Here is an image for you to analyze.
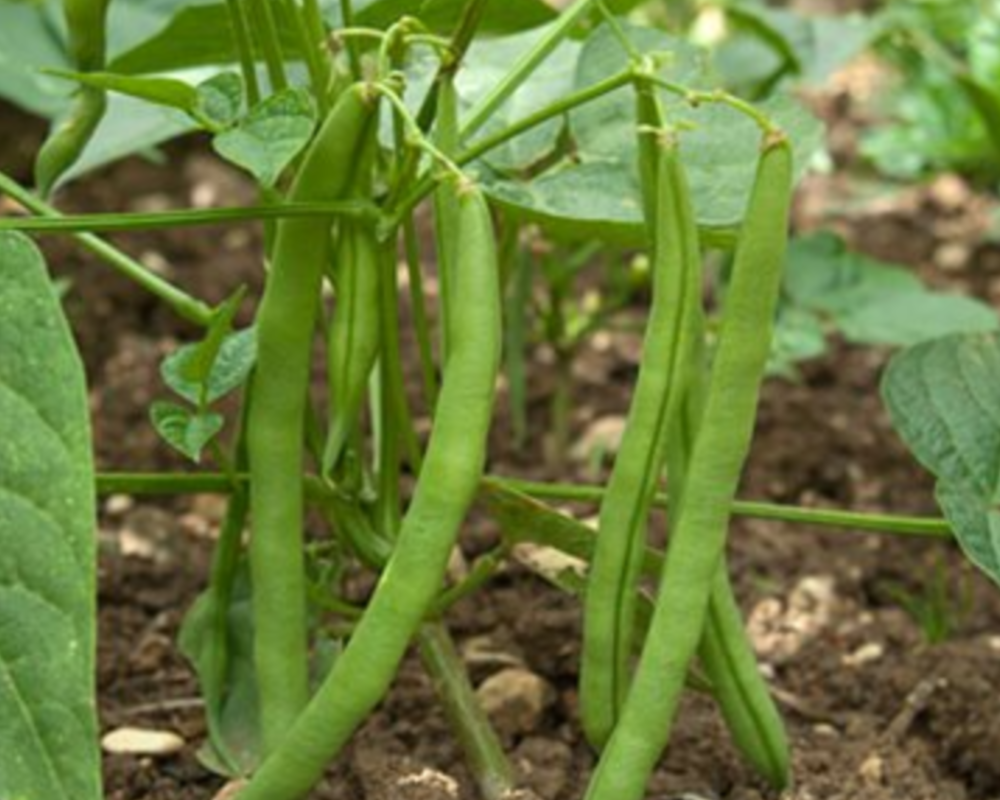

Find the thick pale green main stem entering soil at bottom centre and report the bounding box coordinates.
[417,622,514,800]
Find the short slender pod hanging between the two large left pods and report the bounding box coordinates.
[323,219,380,471]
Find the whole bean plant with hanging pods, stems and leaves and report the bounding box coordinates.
[0,0,1000,800]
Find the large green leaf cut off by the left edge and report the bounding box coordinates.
[0,233,102,800]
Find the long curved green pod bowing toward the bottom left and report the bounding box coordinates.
[239,182,501,800]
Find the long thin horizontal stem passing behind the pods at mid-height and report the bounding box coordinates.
[97,472,953,540]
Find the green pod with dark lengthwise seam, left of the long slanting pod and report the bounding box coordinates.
[580,132,701,748]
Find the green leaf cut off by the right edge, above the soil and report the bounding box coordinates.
[882,333,1000,584]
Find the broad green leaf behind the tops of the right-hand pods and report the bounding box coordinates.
[478,26,821,244]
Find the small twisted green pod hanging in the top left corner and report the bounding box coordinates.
[35,0,110,196]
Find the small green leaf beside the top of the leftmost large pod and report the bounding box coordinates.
[212,89,316,187]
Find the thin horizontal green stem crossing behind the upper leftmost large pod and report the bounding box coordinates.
[0,200,376,233]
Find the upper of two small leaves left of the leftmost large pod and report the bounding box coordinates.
[160,328,257,406]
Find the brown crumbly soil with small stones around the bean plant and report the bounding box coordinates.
[0,43,1000,800]
